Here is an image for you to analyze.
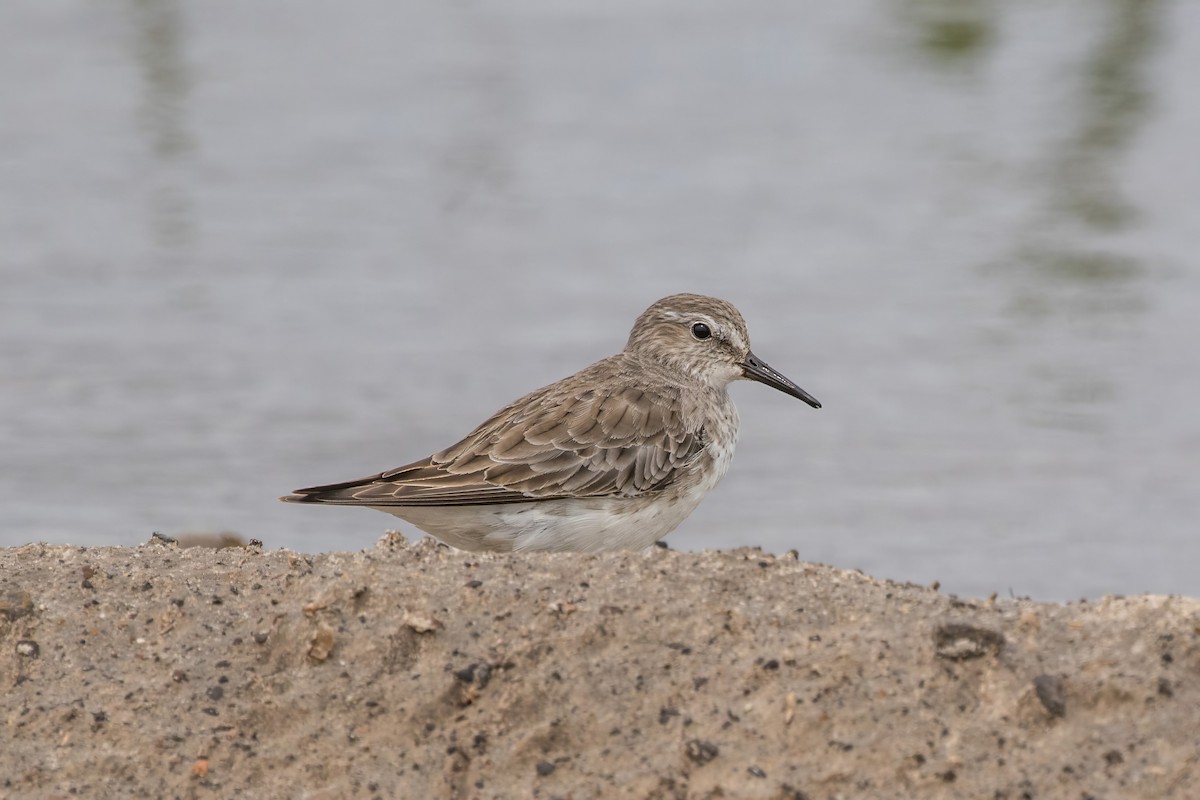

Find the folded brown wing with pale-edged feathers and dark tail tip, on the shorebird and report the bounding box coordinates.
[282,354,704,506]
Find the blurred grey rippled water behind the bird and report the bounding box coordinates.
[0,0,1200,600]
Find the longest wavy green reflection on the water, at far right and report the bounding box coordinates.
[986,0,1163,433]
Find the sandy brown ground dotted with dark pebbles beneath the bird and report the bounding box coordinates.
[0,537,1200,800]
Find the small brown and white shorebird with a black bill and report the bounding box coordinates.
[280,294,821,553]
